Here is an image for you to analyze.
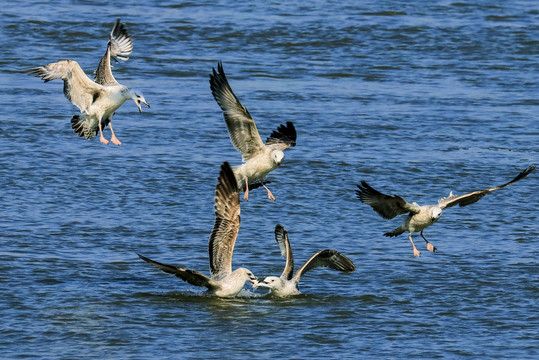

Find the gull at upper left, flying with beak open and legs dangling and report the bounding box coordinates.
[26,19,150,145]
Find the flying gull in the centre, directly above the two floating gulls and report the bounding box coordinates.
[210,62,296,200]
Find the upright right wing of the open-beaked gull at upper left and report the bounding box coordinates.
[95,19,133,85]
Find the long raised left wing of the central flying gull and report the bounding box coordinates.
[210,62,265,161]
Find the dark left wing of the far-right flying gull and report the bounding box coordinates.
[356,180,420,219]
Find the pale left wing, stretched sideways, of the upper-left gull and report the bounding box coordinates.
[26,60,104,111]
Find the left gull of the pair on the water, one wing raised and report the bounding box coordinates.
[138,162,257,297]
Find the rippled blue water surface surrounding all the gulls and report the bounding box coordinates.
[0,0,539,359]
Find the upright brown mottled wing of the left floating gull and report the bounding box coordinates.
[208,162,240,280]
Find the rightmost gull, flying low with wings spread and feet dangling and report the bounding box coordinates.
[356,165,535,256]
